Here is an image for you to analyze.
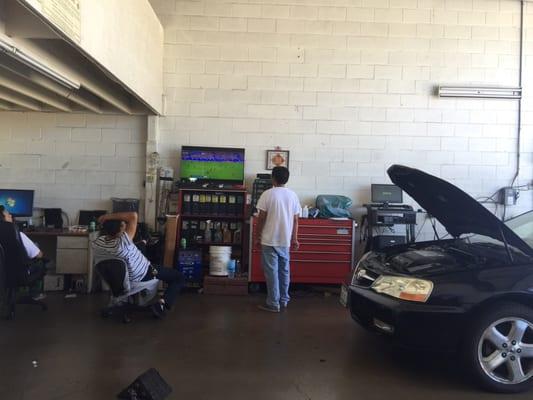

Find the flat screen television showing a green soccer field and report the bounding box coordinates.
[180,146,244,184]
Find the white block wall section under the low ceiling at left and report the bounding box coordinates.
[0,112,146,224]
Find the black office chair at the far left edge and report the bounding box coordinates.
[0,221,48,319]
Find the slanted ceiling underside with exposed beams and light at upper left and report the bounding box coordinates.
[0,0,156,115]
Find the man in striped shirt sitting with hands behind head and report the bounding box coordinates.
[92,212,182,318]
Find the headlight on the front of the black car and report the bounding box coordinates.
[371,275,433,303]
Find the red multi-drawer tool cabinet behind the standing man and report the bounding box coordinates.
[248,218,357,284]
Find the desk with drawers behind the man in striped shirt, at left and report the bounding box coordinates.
[24,230,96,293]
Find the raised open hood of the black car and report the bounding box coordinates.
[387,165,533,255]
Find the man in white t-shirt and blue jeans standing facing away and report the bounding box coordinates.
[255,167,300,312]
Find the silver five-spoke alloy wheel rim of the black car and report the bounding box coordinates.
[478,317,533,385]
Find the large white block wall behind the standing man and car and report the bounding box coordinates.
[151,0,533,234]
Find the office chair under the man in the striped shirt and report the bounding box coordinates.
[95,259,159,323]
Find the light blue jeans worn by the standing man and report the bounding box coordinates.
[261,246,291,308]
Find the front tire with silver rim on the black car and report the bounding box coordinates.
[463,302,533,393]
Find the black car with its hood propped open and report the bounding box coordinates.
[341,165,533,392]
